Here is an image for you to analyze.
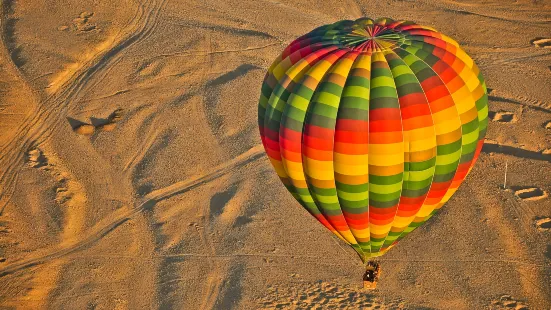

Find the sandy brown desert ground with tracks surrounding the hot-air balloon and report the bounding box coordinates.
[0,0,551,309]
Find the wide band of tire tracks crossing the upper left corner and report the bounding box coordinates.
[0,0,167,213]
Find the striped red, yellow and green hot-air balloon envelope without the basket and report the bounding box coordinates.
[258,18,488,262]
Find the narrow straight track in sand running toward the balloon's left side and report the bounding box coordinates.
[0,145,264,278]
